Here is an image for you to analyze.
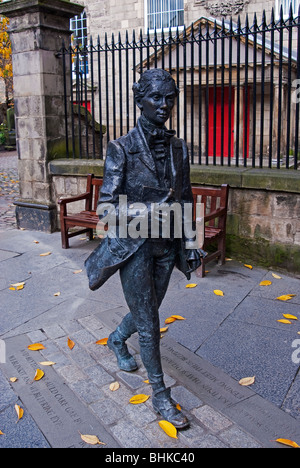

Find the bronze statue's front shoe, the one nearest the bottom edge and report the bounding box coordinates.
[152,388,189,429]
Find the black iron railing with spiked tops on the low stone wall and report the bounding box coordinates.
[60,10,300,169]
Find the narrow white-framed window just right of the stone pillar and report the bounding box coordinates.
[70,12,89,75]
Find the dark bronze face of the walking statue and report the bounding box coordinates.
[139,79,176,127]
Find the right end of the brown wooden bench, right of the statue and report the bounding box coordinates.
[192,184,229,278]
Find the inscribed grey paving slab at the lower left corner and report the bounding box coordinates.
[0,335,118,448]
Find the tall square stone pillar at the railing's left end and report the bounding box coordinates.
[0,0,84,232]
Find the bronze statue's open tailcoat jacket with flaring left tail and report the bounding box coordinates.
[85,121,193,290]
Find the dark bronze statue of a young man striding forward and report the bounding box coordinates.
[86,69,203,428]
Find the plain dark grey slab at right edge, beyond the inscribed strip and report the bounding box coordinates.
[197,320,299,407]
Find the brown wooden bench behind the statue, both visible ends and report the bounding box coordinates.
[58,174,229,277]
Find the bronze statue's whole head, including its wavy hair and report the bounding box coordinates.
[132,68,179,127]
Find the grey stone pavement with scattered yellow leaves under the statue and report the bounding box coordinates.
[0,151,300,453]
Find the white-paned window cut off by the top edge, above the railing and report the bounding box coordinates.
[145,0,184,31]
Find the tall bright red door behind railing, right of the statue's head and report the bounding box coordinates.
[208,86,234,157]
